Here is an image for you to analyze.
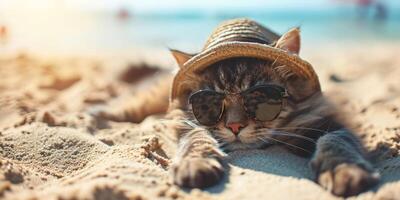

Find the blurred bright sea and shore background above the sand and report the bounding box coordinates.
[0,0,400,55]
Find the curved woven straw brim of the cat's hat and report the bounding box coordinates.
[170,41,321,100]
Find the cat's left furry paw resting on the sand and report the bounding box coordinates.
[172,158,224,188]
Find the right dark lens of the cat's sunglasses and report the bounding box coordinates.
[244,86,282,121]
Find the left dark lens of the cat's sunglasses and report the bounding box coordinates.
[189,91,224,126]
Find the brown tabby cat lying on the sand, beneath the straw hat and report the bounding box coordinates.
[97,21,379,197]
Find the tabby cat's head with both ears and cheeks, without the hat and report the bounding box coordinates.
[172,29,327,151]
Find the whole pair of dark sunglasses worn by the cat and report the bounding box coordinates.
[189,85,289,126]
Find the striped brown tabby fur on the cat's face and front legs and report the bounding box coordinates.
[169,58,378,196]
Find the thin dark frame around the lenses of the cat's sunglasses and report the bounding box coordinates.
[188,84,289,126]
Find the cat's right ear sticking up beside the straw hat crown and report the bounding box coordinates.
[275,27,300,55]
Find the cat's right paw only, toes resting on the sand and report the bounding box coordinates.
[317,163,379,197]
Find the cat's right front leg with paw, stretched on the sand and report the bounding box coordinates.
[310,129,379,197]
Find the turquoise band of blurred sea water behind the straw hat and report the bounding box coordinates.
[131,8,400,48]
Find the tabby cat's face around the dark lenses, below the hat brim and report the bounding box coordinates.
[188,58,293,150]
